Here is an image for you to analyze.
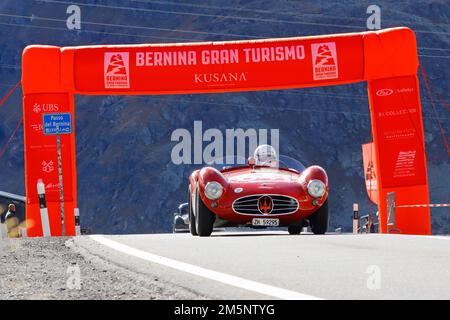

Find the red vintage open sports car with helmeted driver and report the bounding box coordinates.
[188,146,328,236]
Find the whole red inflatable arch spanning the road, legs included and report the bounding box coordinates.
[22,28,431,236]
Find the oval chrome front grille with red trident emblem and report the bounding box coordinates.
[233,194,299,215]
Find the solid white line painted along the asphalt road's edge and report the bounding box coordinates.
[90,235,321,300]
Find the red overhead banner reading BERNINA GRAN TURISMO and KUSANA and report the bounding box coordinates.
[73,37,364,94]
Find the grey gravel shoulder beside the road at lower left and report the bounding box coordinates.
[0,237,204,300]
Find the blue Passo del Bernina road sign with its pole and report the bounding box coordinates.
[42,113,72,236]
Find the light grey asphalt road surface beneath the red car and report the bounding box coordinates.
[75,232,450,299]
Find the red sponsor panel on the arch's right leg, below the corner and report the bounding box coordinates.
[371,77,426,188]
